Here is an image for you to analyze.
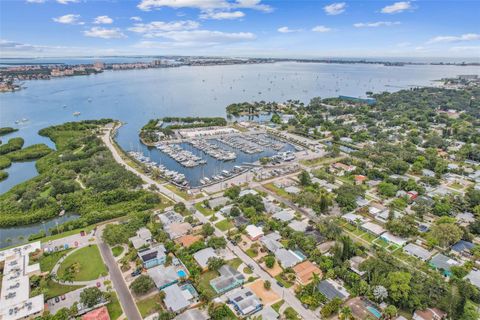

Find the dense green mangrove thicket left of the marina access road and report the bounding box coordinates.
[0,119,161,228]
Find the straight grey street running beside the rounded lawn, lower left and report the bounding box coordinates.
[96,226,142,320]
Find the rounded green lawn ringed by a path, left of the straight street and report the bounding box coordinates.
[58,245,107,281]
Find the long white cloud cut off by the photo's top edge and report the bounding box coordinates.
[137,0,272,12]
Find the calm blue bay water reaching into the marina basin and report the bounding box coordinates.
[0,62,480,242]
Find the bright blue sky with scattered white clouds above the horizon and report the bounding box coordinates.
[0,0,480,59]
